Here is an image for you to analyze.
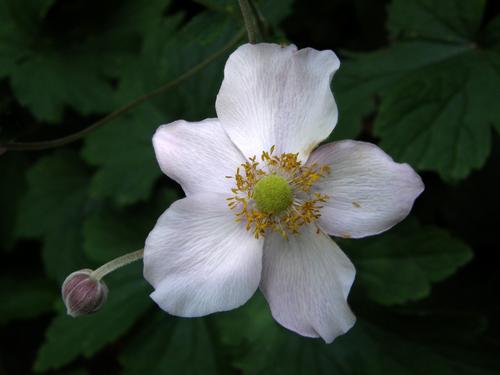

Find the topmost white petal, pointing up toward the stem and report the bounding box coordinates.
[216,43,340,161]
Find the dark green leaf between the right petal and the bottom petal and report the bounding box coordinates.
[341,220,473,305]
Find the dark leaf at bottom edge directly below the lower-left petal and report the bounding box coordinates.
[120,312,219,375]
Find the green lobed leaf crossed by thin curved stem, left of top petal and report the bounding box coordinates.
[83,12,242,206]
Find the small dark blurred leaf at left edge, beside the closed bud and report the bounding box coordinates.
[0,275,59,324]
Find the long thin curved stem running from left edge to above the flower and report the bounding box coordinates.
[0,30,245,151]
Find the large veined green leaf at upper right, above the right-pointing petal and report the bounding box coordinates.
[375,51,500,180]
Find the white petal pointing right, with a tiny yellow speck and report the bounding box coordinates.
[308,141,424,238]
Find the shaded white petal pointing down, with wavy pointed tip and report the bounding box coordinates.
[260,225,356,343]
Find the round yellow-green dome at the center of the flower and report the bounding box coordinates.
[253,174,293,214]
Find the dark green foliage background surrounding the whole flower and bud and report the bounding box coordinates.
[0,0,500,375]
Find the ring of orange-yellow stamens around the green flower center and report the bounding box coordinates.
[226,146,330,238]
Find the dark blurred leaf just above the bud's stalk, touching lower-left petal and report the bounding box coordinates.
[83,190,180,263]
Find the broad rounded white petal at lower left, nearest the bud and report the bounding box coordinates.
[144,194,263,317]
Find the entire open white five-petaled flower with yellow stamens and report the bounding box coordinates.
[144,44,424,343]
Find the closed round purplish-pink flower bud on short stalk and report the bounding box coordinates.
[61,269,108,318]
